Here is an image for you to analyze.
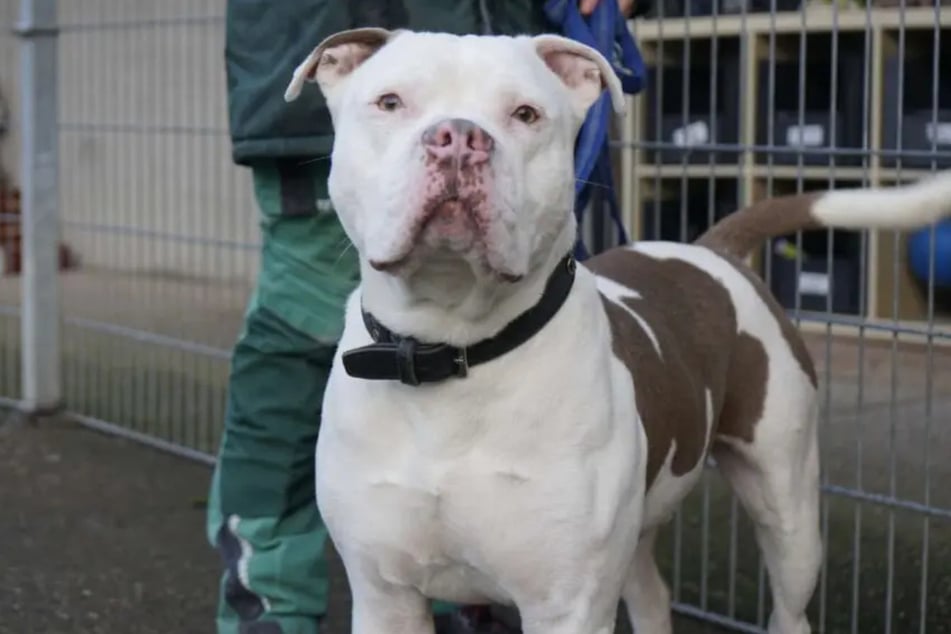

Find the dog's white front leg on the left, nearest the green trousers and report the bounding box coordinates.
[350,575,435,634]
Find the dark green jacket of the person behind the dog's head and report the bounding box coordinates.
[225,0,554,165]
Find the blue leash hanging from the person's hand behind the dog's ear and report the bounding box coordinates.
[545,0,645,260]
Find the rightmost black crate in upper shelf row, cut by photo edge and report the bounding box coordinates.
[882,49,951,168]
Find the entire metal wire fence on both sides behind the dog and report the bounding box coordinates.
[0,0,951,634]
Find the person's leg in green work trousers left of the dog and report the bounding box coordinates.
[207,162,357,634]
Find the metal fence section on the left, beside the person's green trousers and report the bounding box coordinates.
[0,0,258,455]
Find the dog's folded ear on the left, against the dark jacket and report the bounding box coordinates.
[284,28,399,101]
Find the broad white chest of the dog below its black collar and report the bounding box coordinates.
[318,324,643,602]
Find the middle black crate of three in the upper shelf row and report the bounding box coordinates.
[756,46,865,165]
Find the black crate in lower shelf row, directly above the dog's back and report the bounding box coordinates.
[641,180,737,242]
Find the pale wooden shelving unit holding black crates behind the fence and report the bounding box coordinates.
[619,5,951,334]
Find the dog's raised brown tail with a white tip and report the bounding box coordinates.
[696,170,951,258]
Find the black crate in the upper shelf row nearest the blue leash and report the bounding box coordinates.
[642,40,740,164]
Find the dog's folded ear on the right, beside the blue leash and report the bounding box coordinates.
[532,35,624,114]
